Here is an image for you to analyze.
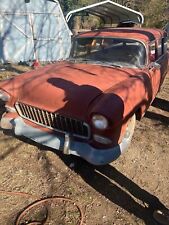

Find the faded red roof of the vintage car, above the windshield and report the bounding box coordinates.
[77,27,164,42]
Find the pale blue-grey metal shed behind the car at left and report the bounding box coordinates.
[0,0,71,63]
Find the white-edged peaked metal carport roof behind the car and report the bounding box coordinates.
[66,0,144,24]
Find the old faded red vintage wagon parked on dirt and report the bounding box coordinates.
[0,28,169,165]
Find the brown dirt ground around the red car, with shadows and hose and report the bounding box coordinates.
[0,63,169,225]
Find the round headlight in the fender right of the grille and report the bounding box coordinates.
[92,115,108,130]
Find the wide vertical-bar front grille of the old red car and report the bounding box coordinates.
[15,102,90,139]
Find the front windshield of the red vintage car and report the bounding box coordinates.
[70,37,146,67]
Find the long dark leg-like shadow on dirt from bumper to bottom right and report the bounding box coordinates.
[60,155,165,225]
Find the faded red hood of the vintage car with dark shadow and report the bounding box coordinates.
[0,62,141,119]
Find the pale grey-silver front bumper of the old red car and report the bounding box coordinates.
[1,117,130,165]
